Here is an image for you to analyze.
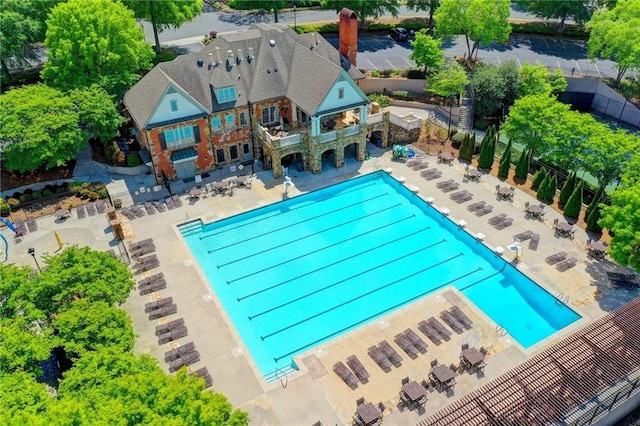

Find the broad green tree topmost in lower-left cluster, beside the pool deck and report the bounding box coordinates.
[31,246,134,313]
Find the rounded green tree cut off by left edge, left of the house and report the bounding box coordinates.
[0,84,86,173]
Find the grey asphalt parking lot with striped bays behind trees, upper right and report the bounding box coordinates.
[327,33,616,77]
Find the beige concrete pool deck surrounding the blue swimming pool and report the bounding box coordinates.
[2,145,638,425]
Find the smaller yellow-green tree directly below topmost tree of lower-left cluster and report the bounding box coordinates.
[52,299,135,357]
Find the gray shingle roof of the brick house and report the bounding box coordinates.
[124,24,364,128]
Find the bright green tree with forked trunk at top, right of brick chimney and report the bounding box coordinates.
[435,0,511,68]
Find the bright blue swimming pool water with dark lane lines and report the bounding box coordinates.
[180,172,579,375]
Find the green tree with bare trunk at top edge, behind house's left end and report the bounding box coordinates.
[122,0,200,53]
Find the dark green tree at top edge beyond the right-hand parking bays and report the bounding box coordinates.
[514,0,593,34]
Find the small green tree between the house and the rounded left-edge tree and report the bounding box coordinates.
[69,84,125,143]
